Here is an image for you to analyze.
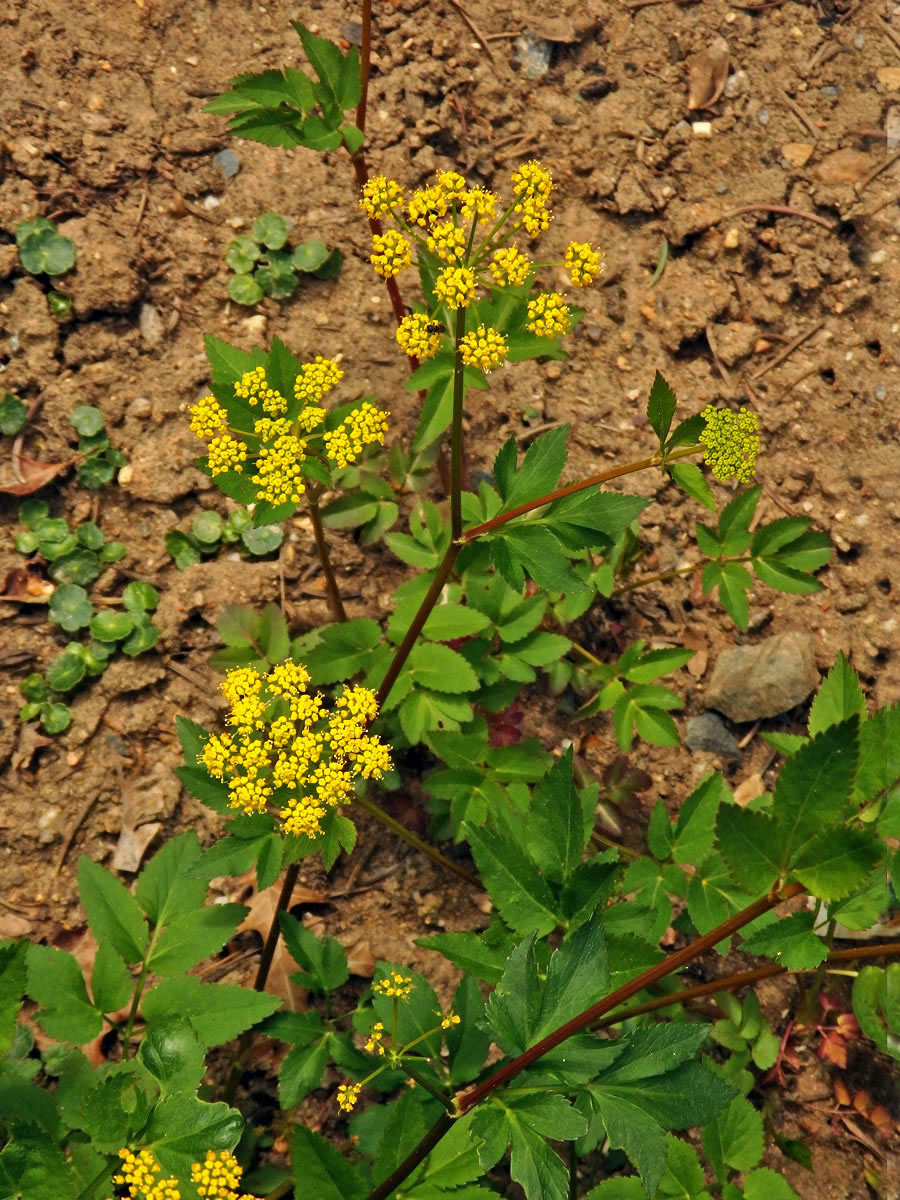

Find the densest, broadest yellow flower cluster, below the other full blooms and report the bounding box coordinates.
[198,661,391,838]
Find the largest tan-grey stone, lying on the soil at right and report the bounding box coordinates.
[706,630,818,721]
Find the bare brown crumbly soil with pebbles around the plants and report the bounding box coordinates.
[0,0,900,1200]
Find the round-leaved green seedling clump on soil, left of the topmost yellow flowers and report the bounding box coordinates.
[226,212,343,305]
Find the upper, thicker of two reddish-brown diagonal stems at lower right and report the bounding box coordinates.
[456,883,805,1116]
